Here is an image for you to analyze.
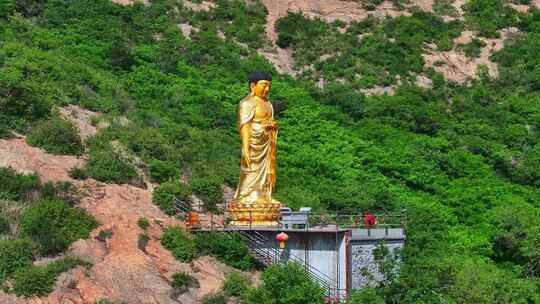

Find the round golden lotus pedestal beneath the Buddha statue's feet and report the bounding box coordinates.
[227,202,282,226]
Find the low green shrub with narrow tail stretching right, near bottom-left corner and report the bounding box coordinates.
[13,257,90,297]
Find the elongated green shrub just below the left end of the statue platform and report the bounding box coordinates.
[196,232,257,270]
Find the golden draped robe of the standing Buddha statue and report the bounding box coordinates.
[233,96,277,204]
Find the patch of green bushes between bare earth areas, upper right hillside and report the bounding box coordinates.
[276,11,463,85]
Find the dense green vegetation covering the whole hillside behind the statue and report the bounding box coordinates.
[0,0,540,303]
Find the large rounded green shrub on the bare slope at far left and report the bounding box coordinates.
[21,200,98,254]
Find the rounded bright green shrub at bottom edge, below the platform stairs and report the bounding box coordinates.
[246,263,324,304]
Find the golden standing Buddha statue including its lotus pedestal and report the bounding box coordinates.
[227,72,281,225]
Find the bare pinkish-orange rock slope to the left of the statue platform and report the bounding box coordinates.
[0,138,249,304]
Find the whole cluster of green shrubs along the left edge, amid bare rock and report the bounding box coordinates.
[0,168,97,297]
